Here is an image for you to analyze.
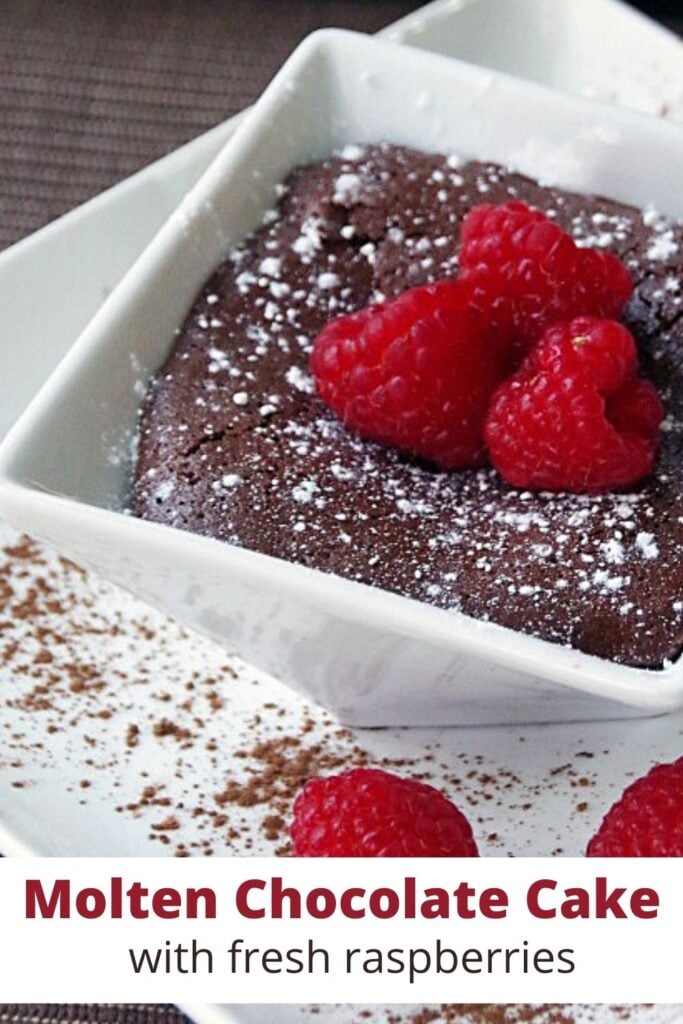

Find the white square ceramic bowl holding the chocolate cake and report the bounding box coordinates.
[0,25,683,725]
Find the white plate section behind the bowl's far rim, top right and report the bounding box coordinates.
[382,0,683,121]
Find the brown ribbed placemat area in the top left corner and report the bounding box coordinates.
[0,0,420,249]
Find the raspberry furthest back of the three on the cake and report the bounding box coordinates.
[460,202,633,353]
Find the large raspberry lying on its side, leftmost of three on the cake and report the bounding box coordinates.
[311,281,506,469]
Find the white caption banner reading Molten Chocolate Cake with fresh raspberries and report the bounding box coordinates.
[0,856,683,1004]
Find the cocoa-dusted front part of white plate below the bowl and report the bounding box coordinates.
[0,526,680,872]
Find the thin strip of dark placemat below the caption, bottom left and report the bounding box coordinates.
[0,1002,187,1024]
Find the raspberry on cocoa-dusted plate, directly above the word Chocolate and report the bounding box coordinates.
[291,768,478,857]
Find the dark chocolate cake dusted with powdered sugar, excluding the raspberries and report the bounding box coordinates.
[132,144,683,669]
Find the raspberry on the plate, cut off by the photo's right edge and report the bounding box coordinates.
[586,758,683,857]
